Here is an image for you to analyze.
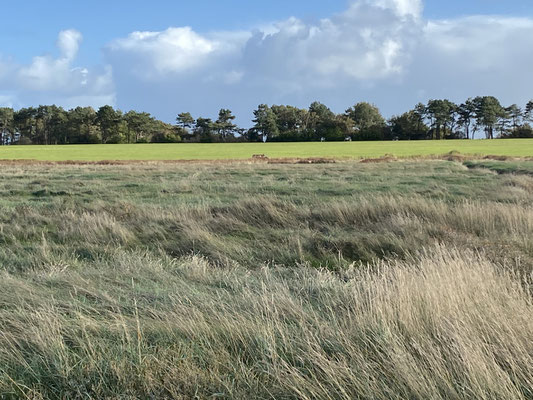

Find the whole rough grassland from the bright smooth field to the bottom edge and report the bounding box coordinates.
[0,159,533,399]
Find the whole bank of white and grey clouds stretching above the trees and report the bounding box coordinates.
[0,0,533,125]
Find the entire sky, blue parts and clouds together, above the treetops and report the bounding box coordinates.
[0,0,533,126]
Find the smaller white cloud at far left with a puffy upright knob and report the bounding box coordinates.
[0,29,115,107]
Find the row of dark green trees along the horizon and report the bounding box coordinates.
[0,96,533,145]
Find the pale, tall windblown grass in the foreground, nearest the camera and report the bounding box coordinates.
[0,246,533,399]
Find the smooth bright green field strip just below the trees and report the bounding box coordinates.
[0,139,533,161]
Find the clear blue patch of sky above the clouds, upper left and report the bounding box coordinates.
[0,0,346,61]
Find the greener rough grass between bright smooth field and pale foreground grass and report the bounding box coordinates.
[0,161,533,269]
